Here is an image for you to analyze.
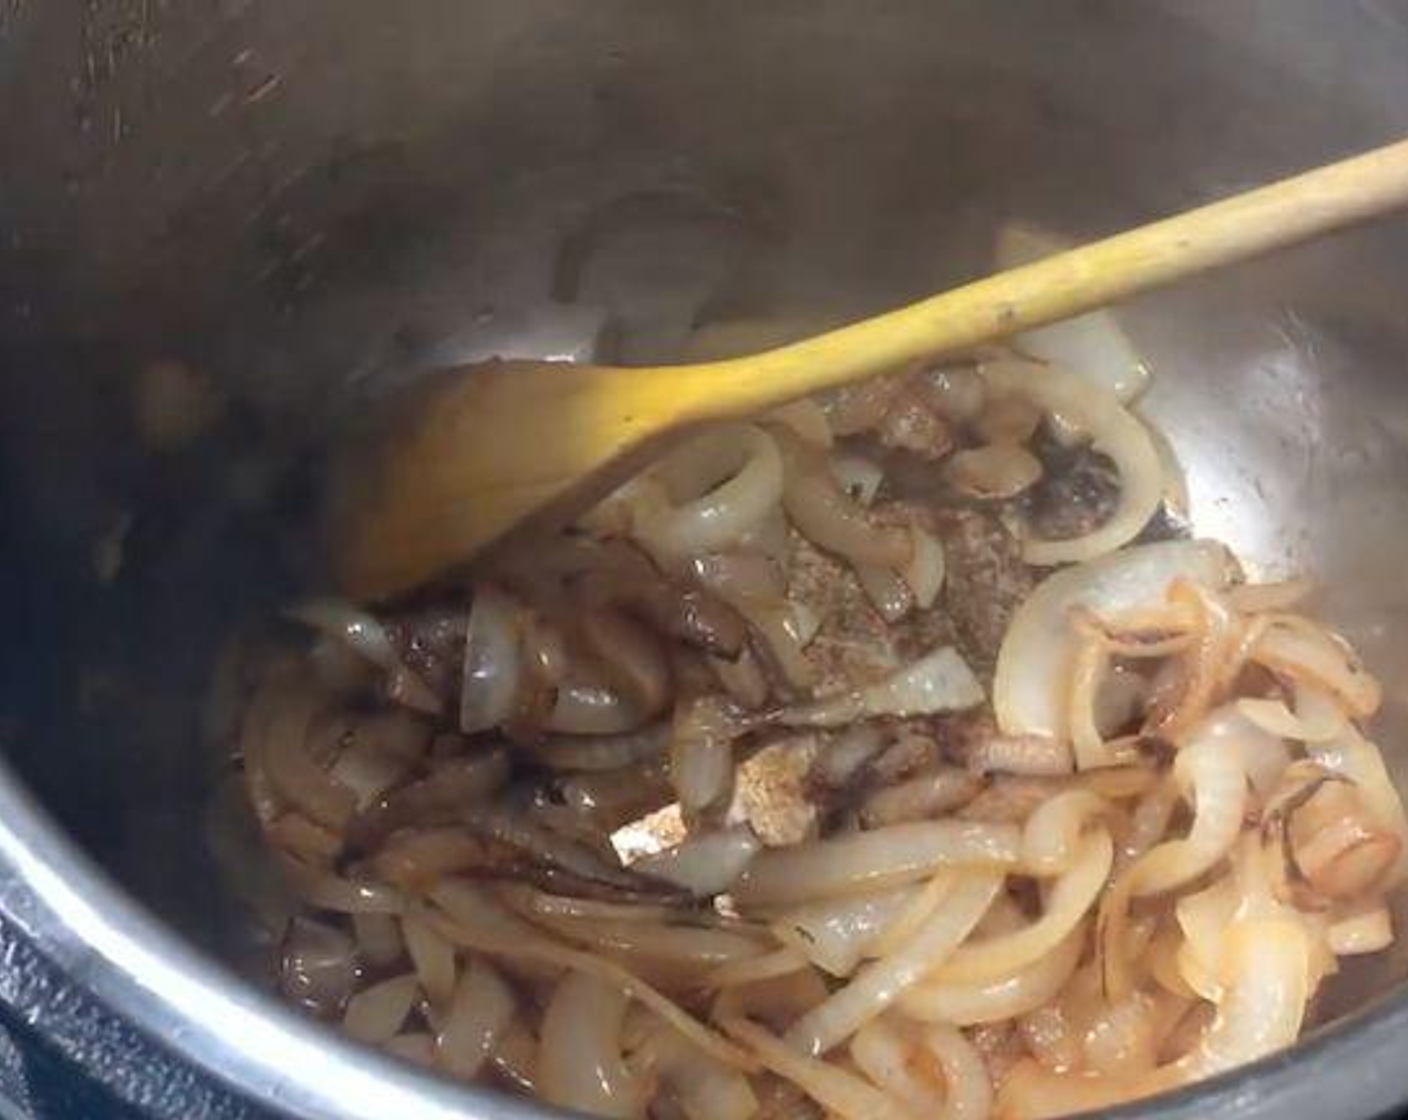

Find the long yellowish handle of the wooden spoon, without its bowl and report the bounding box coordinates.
[669,141,1408,418]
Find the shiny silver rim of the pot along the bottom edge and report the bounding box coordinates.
[0,759,1408,1120]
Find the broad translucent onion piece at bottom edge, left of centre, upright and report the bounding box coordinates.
[538,972,648,1120]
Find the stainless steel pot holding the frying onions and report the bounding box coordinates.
[0,0,1408,1120]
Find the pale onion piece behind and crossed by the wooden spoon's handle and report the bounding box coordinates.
[997,224,1149,404]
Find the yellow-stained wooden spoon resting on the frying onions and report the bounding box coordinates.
[328,141,1408,599]
